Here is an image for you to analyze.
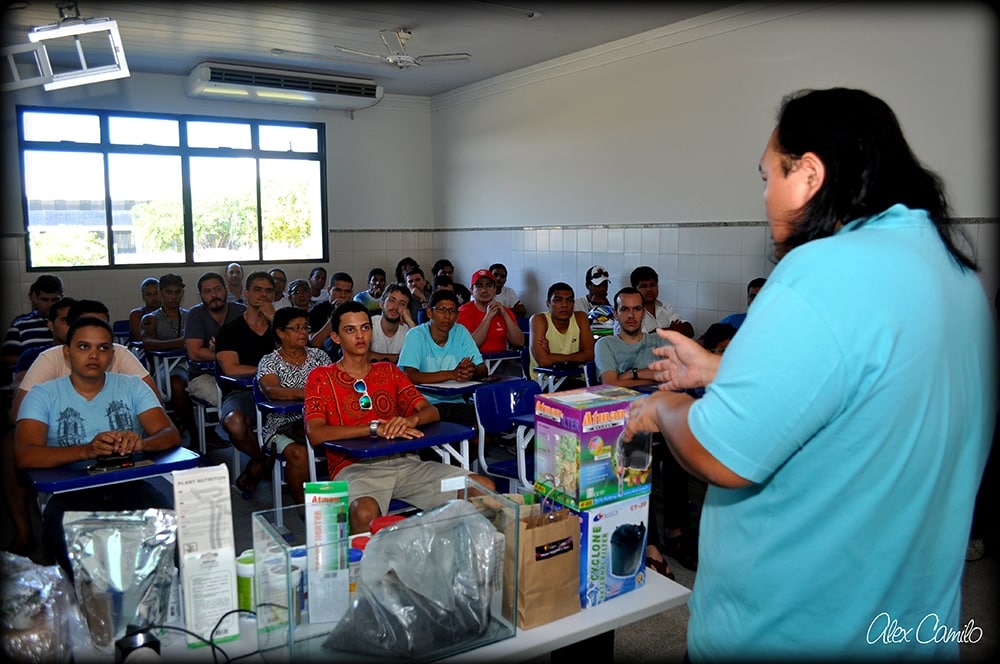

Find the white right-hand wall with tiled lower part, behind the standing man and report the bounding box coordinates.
[420,3,998,332]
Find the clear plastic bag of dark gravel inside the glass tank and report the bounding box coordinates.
[323,500,503,658]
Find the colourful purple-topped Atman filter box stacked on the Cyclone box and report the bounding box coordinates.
[535,385,652,509]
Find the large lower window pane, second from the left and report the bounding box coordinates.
[108,154,185,264]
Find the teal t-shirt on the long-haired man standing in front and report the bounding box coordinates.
[688,205,996,661]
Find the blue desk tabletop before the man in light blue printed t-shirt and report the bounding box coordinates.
[28,447,201,493]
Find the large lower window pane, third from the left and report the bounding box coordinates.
[191,157,259,263]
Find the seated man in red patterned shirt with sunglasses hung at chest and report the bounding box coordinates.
[304,302,493,533]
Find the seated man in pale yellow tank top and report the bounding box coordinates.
[529,281,594,387]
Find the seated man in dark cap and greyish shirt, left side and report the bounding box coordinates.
[142,274,196,436]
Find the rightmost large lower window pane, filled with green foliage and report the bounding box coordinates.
[260,159,323,261]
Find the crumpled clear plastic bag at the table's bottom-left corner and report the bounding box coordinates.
[0,551,90,662]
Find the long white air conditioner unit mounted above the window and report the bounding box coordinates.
[187,62,383,111]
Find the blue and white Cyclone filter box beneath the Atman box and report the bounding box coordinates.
[577,487,655,609]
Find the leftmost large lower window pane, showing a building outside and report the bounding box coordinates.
[24,150,109,267]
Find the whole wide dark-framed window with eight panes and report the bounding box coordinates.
[18,107,328,270]
